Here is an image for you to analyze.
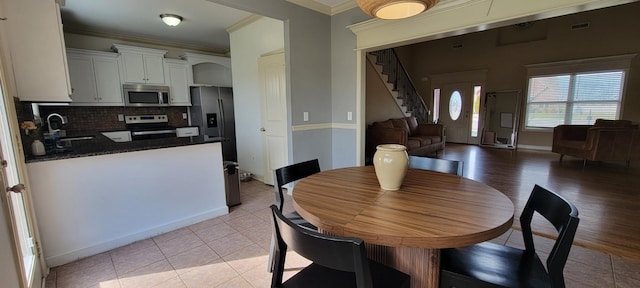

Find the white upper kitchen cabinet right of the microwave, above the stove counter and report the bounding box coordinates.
[165,59,193,106]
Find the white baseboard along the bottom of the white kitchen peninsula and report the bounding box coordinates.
[45,206,229,267]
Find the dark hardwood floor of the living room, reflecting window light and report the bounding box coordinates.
[440,143,640,261]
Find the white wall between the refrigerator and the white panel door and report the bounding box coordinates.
[229,17,284,179]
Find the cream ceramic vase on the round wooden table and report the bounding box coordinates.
[373,144,409,191]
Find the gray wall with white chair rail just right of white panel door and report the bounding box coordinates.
[208,0,336,169]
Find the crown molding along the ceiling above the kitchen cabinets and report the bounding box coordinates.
[64,28,229,56]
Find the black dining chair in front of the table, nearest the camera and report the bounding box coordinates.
[271,205,411,288]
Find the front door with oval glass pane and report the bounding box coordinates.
[440,82,473,143]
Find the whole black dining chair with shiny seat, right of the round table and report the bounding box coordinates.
[440,185,580,288]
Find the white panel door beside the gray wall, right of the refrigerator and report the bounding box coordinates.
[258,53,288,185]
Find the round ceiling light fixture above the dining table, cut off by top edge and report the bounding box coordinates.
[358,0,440,19]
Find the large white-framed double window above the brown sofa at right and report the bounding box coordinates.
[525,55,635,129]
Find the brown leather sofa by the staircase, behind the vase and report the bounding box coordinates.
[366,117,444,159]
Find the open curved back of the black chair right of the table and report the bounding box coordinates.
[520,185,580,287]
